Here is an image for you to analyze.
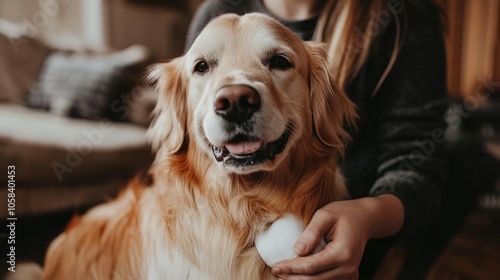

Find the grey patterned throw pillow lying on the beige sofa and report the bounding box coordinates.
[26,46,148,119]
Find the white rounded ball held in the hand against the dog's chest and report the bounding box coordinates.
[255,215,325,267]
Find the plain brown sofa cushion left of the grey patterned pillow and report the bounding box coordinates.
[0,19,52,104]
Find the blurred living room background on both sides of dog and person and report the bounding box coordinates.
[0,0,500,280]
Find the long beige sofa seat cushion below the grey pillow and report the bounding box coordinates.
[0,104,153,186]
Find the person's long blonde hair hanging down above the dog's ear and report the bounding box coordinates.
[313,0,405,94]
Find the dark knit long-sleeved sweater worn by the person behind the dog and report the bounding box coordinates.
[187,0,446,239]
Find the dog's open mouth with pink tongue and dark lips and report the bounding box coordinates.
[212,126,291,167]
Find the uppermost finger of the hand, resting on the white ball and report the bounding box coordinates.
[293,209,334,256]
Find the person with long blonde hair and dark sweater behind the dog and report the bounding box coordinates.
[186,0,446,279]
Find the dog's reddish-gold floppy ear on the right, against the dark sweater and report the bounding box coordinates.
[307,42,357,153]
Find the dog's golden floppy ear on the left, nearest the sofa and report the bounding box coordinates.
[148,57,187,155]
